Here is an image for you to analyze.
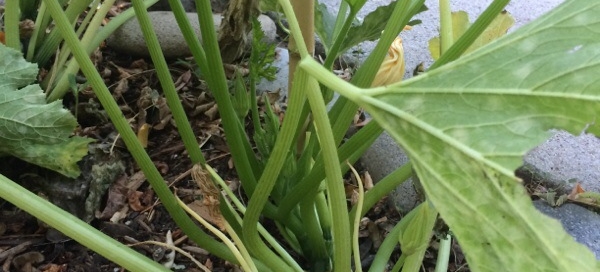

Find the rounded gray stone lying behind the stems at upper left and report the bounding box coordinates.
[106,11,277,58]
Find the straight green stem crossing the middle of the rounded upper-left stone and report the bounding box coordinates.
[132,0,206,164]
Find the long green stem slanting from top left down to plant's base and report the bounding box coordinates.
[44,0,237,264]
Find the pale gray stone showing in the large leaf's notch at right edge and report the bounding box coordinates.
[520,131,600,194]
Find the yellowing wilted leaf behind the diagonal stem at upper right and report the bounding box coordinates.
[429,11,515,60]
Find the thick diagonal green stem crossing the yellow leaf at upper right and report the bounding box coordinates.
[429,0,510,70]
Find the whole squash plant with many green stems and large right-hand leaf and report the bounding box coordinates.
[0,0,600,271]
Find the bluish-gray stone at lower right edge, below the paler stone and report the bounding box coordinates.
[533,200,600,259]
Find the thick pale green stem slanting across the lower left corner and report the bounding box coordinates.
[0,175,169,271]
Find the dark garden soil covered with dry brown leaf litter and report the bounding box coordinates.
[0,2,468,272]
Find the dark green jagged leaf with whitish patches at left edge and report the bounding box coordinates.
[0,45,91,177]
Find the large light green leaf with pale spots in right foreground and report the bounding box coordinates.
[314,0,600,271]
